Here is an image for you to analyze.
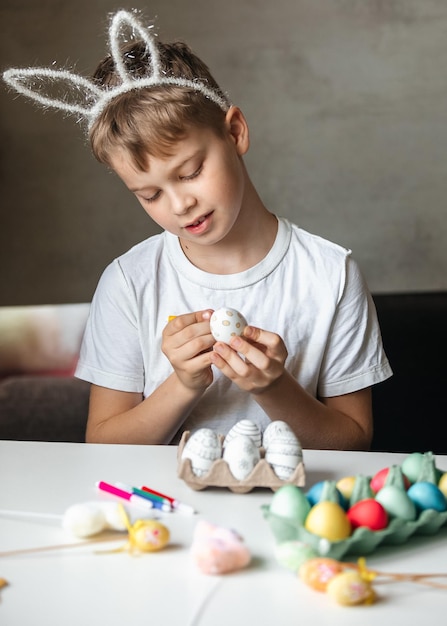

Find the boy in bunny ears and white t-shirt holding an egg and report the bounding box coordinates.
[5,11,391,449]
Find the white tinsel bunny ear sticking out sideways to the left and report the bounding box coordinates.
[3,67,103,118]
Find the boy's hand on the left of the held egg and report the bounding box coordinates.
[161,309,215,389]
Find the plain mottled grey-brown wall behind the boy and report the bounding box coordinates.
[0,0,447,304]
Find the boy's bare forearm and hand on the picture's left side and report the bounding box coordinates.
[86,311,214,444]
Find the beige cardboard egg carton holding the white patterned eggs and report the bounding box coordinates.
[177,430,306,493]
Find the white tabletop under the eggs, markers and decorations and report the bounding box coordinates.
[0,441,447,626]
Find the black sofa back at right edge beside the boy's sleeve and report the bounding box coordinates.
[372,292,447,454]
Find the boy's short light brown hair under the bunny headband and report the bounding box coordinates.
[89,42,230,171]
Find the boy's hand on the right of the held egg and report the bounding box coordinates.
[210,326,287,394]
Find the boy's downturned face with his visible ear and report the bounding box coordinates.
[107,107,248,248]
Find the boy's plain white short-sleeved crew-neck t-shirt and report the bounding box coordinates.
[76,218,392,440]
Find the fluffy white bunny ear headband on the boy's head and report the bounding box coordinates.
[3,11,230,128]
